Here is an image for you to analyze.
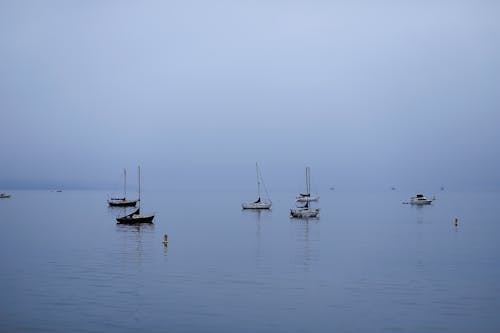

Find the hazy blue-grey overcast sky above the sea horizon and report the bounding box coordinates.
[0,0,500,191]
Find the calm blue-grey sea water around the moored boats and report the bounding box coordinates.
[0,190,500,333]
